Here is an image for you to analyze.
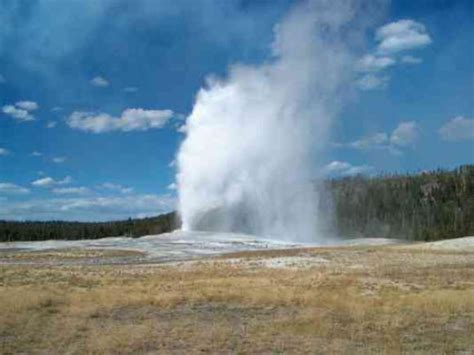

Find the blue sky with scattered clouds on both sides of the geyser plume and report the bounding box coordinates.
[0,0,474,220]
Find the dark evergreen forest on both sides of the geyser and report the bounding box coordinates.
[0,165,474,241]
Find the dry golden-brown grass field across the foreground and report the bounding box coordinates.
[0,246,474,354]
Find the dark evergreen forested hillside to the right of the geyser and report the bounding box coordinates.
[328,165,474,241]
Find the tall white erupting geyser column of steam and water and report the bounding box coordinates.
[177,0,374,241]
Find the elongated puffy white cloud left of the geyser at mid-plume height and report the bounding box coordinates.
[67,108,173,133]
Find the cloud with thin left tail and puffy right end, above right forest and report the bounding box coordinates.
[336,121,419,155]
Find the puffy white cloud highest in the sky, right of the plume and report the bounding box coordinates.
[375,20,432,54]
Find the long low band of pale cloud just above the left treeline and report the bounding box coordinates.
[0,194,176,221]
